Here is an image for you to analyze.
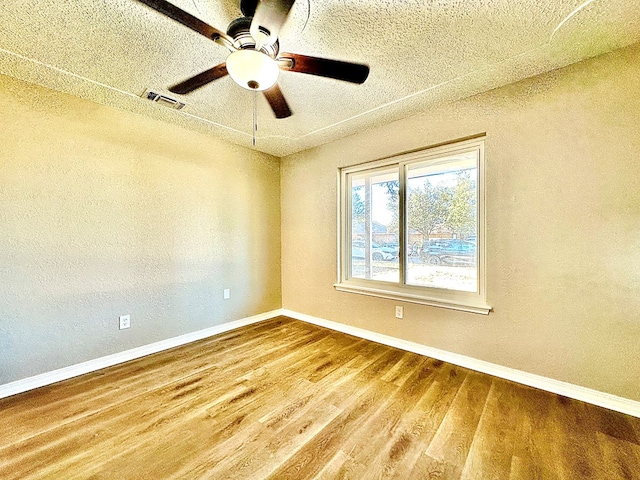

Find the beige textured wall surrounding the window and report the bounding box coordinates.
[281,41,640,400]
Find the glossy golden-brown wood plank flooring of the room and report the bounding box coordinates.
[0,317,640,480]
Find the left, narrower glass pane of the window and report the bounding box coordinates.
[349,167,400,283]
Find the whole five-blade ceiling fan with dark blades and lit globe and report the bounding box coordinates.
[139,0,369,118]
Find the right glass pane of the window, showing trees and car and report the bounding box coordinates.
[406,150,478,292]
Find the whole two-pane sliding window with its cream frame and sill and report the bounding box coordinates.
[335,138,490,314]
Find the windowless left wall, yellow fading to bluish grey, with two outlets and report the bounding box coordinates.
[0,76,281,384]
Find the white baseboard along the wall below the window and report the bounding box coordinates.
[279,309,640,418]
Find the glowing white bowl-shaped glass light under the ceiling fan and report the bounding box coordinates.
[227,50,280,91]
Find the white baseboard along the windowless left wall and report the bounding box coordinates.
[0,310,281,398]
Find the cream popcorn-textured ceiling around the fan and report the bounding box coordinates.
[0,0,640,156]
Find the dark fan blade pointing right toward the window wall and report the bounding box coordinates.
[277,53,369,83]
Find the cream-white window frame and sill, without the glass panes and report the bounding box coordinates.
[334,136,491,315]
